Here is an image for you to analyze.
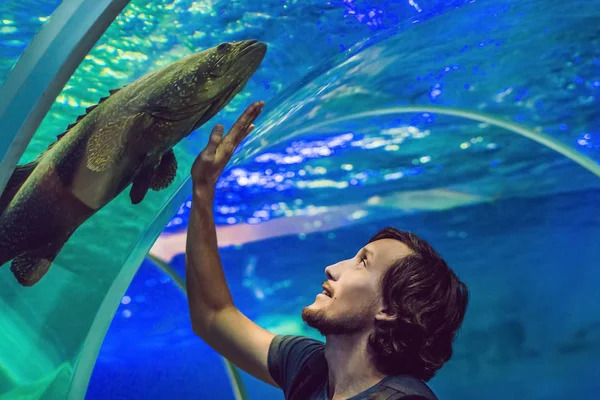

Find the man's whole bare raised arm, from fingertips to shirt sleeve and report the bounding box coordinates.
[186,102,278,387]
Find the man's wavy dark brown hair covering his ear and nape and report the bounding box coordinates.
[369,228,469,381]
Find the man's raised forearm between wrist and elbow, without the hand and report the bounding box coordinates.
[186,190,233,334]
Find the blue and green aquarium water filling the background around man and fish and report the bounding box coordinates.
[0,0,600,399]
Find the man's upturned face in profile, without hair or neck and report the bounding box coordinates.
[302,239,411,336]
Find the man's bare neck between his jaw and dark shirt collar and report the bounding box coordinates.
[325,333,385,400]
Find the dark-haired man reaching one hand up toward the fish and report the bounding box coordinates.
[186,102,468,400]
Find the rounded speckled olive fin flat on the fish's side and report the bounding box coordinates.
[86,126,127,172]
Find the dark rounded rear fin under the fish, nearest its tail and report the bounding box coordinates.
[10,240,66,286]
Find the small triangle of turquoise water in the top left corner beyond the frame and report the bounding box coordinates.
[0,0,60,86]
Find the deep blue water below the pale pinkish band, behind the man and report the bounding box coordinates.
[87,190,600,399]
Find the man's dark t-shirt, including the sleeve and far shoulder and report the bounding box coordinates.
[268,335,437,400]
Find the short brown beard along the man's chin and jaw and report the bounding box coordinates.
[302,307,368,336]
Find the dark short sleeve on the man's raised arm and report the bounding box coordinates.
[268,335,324,395]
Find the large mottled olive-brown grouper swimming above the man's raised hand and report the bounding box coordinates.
[0,40,267,286]
